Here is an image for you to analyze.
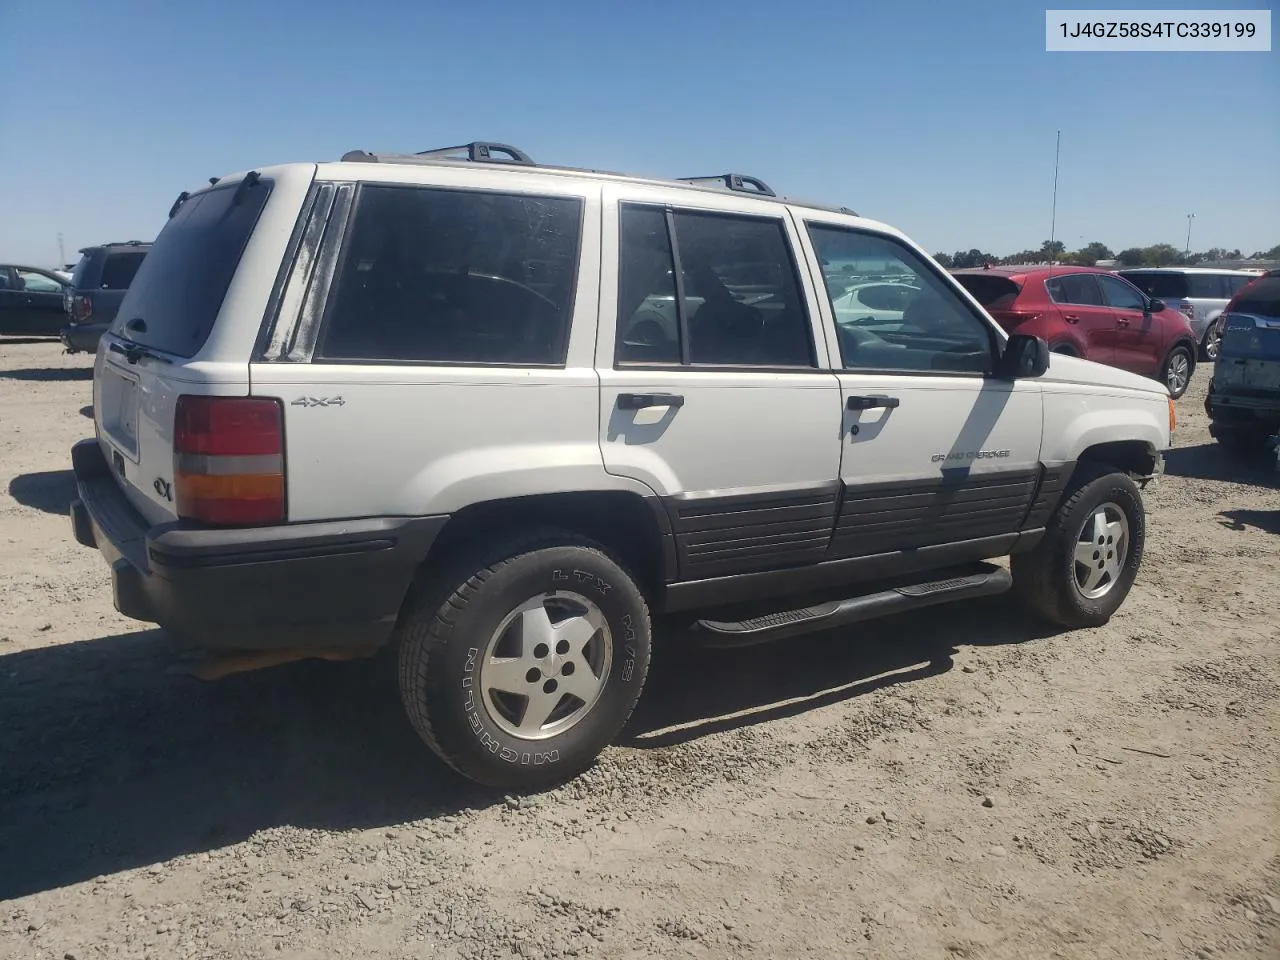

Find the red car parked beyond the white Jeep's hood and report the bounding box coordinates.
[954,266,1197,398]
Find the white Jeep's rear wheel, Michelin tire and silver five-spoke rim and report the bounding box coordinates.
[398,531,650,791]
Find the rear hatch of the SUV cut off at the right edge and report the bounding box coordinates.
[1213,275,1280,398]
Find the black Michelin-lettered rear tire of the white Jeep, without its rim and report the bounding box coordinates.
[398,530,652,791]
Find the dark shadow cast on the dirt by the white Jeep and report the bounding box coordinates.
[0,600,1043,900]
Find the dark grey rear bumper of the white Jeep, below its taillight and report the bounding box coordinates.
[70,440,448,650]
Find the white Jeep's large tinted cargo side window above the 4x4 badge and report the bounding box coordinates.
[316,186,582,365]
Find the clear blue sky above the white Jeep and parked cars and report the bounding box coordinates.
[0,0,1280,264]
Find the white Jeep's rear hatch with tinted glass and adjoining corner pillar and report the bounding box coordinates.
[93,168,294,524]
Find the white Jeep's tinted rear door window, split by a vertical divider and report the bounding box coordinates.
[617,205,814,367]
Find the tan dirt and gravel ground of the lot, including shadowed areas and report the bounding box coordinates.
[0,343,1280,960]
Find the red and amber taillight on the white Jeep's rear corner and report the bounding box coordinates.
[173,396,284,526]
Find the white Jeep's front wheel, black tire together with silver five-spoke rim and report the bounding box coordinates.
[1010,465,1146,627]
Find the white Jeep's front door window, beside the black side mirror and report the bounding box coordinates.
[809,224,992,374]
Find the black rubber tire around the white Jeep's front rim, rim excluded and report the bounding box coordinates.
[1010,463,1146,627]
